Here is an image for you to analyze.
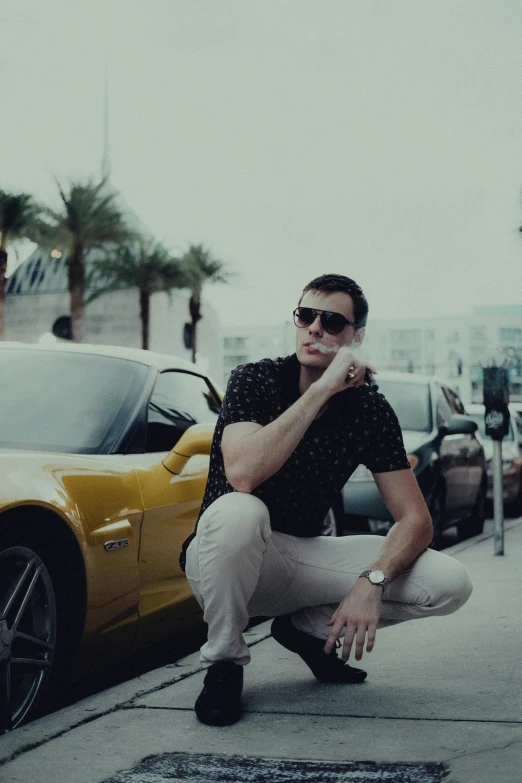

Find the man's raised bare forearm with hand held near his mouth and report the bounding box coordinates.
[221,346,375,492]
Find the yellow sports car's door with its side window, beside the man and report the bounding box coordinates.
[138,371,220,636]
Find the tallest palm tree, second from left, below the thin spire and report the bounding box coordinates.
[30,180,132,342]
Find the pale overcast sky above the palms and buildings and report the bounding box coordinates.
[0,0,522,325]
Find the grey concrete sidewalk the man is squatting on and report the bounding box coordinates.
[0,520,522,783]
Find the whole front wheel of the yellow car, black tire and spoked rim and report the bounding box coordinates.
[0,515,82,734]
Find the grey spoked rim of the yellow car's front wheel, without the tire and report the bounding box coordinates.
[0,534,57,733]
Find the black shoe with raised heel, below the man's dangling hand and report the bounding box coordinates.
[272,615,366,684]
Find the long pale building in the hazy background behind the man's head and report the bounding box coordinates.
[223,305,522,402]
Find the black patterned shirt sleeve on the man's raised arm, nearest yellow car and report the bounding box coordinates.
[221,363,270,427]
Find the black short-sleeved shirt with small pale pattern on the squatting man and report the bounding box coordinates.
[180,354,410,568]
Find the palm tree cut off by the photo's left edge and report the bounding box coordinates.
[0,190,39,340]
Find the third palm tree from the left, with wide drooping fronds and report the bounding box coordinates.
[87,239,187,349]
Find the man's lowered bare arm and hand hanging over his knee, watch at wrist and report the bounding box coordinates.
[324,470,433,661]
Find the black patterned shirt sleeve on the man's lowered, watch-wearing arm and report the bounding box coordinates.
[361,390,410,473]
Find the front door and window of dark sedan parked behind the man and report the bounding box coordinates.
[436,384,468,519]
